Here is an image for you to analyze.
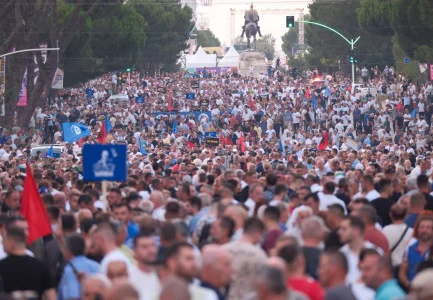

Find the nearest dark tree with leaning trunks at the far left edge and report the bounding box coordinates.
[0,0,109,128]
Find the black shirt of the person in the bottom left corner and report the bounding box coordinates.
[0,255,55,299]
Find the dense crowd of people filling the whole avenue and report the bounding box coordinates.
[0,63,433,300]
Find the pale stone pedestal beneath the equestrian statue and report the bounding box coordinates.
[239,50,268,78]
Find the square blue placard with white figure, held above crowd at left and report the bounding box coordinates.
[83,144,127,181]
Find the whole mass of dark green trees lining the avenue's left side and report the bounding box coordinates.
[0,0,192,127]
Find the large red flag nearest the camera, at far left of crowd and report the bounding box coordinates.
[20,163,52,245]
